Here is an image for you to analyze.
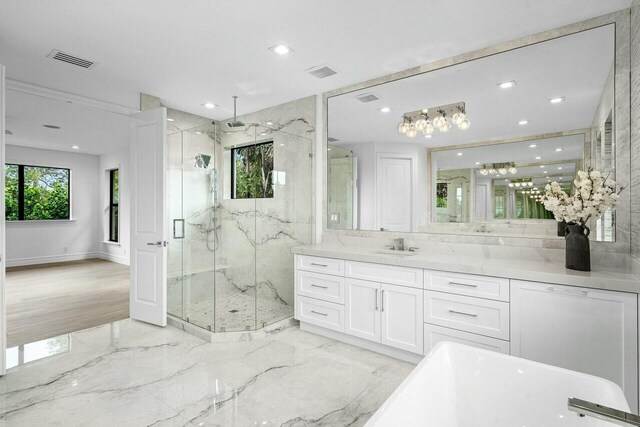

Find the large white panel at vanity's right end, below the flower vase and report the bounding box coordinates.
[511,281,638,412]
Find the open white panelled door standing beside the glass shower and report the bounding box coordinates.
[129,108,168,326]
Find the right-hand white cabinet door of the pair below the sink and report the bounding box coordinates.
[380,283,424,354]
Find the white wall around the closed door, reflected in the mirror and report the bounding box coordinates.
[339,143,429,231]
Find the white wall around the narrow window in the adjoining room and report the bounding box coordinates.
[98,148,130,265]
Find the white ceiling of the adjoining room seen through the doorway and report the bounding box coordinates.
[5,90,129,155]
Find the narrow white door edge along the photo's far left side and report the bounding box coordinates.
[0,64,7,375]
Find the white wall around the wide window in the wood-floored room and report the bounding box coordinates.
[5,145,100,266]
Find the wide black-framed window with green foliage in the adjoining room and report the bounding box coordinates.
[5,164,71,221]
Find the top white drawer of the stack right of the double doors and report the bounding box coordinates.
[424,270,509,301]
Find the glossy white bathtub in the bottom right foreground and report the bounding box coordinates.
[365,342,629,427]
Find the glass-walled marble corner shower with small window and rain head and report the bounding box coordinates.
[168,123,312,332]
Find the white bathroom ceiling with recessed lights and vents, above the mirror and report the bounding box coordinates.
[0,0,631,119]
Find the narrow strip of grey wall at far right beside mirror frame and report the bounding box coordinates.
[631,0,640,258]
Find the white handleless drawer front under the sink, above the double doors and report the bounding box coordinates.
[345,261,424,289]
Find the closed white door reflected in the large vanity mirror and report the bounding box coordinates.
[376,154,413,231]
